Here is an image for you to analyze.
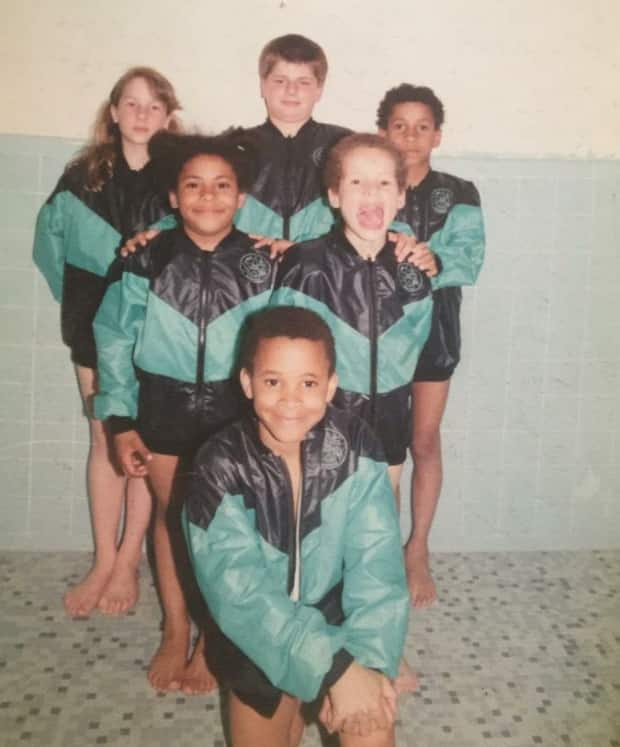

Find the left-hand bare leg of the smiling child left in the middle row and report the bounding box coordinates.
[148,454,190,691]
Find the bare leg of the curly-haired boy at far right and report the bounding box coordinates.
[405,380,450,607]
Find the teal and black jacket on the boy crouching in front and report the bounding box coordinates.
[184,407,409,715]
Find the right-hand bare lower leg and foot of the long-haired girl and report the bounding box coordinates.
[97,478,153,615]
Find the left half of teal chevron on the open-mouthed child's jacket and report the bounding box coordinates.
[270,287,370,394]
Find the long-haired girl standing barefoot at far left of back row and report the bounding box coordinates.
[34,67,180,617]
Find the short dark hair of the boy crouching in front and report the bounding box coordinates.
[239,306,336,375]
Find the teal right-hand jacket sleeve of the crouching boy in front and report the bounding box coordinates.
[342,450,409,678]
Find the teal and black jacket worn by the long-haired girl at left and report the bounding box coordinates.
[34,152,172,368]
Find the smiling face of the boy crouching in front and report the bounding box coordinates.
[241,337,337,456]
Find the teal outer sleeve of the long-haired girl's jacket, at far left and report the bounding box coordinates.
[32,180,69,301]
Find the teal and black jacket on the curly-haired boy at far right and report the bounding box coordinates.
[392,170,485,381]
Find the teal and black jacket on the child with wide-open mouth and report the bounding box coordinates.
[271,229,432,464]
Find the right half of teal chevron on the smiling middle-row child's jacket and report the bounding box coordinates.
[204,290,271,381]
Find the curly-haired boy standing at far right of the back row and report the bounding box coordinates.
[377,84,484,607]
